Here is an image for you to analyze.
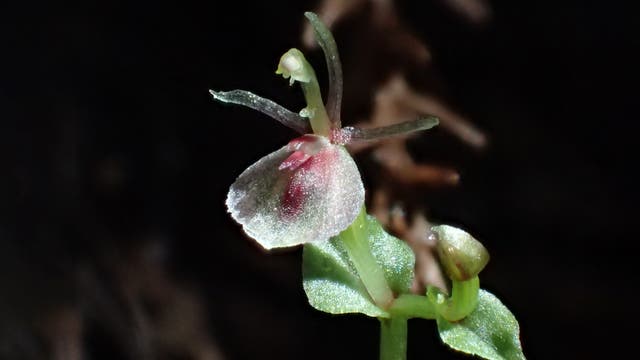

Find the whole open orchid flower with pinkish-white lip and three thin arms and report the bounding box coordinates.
[210,12,438,249]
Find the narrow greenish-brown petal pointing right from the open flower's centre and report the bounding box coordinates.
[340,116,440,143]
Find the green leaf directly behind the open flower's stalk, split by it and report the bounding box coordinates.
[302,216,415,317]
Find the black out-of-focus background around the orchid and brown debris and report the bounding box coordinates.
[0,1,639,359]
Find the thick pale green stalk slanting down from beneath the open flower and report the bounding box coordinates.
[339,206,393,309]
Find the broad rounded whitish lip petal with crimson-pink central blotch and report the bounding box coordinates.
[227,137,364,249]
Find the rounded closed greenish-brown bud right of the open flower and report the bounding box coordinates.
[431,225,489,281]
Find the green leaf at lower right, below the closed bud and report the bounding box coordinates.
[438,290,525,360]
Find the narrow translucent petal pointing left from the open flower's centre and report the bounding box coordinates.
[209,90,311,134]
